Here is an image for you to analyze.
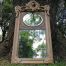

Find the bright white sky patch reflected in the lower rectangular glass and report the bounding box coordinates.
[33,34,46,58]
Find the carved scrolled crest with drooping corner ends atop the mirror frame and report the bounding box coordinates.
[15,0,49,16]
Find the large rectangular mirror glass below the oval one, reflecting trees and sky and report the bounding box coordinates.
[18,30,47,58]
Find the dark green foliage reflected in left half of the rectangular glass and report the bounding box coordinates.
[19,31,33,58]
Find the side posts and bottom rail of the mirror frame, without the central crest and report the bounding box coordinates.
[11,0,53,64]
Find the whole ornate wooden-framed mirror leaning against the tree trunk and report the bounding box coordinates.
[12,1,53,64]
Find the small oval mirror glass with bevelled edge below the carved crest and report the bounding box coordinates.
[23,12,43,26]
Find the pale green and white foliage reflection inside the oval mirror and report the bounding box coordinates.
[24,13,42,26]
